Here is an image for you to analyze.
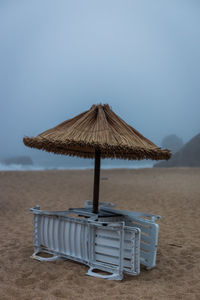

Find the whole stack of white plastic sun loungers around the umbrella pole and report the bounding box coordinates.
[30,201,161,280]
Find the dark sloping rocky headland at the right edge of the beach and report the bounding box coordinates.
[154,134,200,168]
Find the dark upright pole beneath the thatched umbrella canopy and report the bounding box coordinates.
[92,149,101,214]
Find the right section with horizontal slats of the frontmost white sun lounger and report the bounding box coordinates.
[87,222,140,280]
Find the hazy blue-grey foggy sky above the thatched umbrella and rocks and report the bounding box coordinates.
[0,0,200,157]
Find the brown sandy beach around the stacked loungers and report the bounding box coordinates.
[0,168,200,300]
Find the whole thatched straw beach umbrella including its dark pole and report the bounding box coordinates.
[23,104,171,213]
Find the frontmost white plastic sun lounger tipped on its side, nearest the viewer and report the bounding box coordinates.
[31,206,140,280]
